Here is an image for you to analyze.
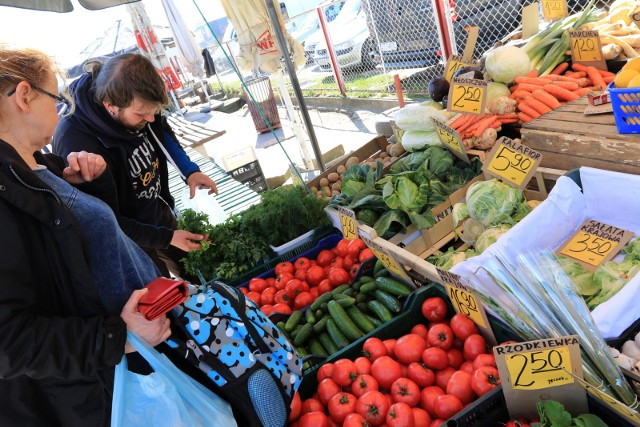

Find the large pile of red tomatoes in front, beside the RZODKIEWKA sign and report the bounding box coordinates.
[290,297,500,427]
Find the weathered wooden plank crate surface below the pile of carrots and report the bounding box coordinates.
[521,96,640,174]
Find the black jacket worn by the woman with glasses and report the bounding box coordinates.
[0,141,126,427]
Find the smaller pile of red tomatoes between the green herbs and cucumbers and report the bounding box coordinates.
[240,239,374,316]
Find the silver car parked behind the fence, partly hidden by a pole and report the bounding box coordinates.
[310,0,376,68]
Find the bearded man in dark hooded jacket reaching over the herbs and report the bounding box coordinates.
[53,54,217,281]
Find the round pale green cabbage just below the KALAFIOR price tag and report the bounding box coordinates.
[466,179,525,227]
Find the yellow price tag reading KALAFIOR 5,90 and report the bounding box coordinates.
[482,137,542,189]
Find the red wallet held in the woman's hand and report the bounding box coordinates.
[138,277,189,320]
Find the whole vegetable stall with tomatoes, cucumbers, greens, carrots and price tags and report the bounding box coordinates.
[176,0,640,427]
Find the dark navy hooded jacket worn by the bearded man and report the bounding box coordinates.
[52,74,198,248]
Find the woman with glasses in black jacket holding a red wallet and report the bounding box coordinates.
[0,45,170,427]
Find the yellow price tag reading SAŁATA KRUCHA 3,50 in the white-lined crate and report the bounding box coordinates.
[558,219,633,270]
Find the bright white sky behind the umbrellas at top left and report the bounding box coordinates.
[0,0,224,66]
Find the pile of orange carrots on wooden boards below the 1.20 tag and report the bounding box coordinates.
[510,62,616,123]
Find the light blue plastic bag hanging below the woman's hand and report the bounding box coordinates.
[111,332,237,427]
